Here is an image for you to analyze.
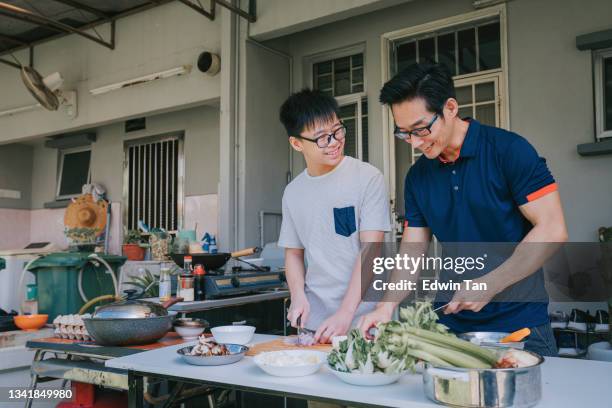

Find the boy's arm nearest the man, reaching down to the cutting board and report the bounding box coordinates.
[315,231,385,343]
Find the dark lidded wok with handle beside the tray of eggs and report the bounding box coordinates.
[83,298,183,346]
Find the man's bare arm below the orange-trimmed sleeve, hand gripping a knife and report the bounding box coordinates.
[444,191,567,314]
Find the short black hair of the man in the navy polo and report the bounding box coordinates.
[380,63,455,115]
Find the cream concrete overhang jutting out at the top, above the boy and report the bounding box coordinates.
[250,0,412,40]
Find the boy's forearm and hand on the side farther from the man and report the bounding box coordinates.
[285,248,310,327]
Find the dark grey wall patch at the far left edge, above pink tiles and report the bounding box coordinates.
[0,144,32,209]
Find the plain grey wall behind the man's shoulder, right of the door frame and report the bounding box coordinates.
[508,0,612,241]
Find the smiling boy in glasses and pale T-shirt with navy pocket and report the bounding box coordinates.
[278,89,390,343]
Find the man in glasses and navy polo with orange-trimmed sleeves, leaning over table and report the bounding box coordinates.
[360,64,567,356]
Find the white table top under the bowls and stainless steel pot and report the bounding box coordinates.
[106,334,612,408]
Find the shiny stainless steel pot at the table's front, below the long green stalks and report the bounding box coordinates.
[423,350,544,408]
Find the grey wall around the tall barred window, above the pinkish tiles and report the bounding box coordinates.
[32,106,219,209]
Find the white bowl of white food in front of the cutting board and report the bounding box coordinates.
[253,350,327,377]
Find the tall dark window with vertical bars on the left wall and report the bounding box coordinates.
[124,135,183,231]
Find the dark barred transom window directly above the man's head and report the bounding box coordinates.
[393,19,501,76]
